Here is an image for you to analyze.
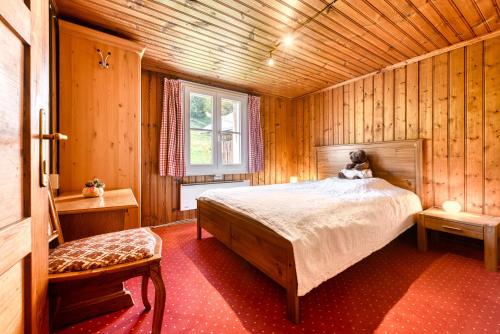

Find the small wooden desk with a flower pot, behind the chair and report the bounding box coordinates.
[55,189,139,241]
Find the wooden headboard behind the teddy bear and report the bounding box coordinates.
[316,139,423,198]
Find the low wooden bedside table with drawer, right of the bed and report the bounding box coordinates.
[417,208,500,271]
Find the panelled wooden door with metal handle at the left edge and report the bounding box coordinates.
[0,0,48,333]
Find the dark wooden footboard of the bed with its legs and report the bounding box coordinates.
[197,200,300,323]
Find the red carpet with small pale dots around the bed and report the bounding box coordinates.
[60,223,500,333]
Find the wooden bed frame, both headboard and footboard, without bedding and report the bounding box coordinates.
[197,139,423,323]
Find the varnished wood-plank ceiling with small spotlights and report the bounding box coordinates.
[56,0,500,98]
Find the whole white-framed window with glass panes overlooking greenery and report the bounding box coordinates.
[182,82,248,175]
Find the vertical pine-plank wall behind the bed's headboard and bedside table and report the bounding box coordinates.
[292,37,500,215]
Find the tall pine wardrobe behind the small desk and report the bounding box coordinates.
[59,20,144,228]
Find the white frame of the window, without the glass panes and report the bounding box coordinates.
[181,81,248,176]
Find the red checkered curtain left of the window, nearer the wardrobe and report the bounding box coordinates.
[159,78,186,178]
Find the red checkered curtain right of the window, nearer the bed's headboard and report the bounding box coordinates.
[248,95,264,173]
